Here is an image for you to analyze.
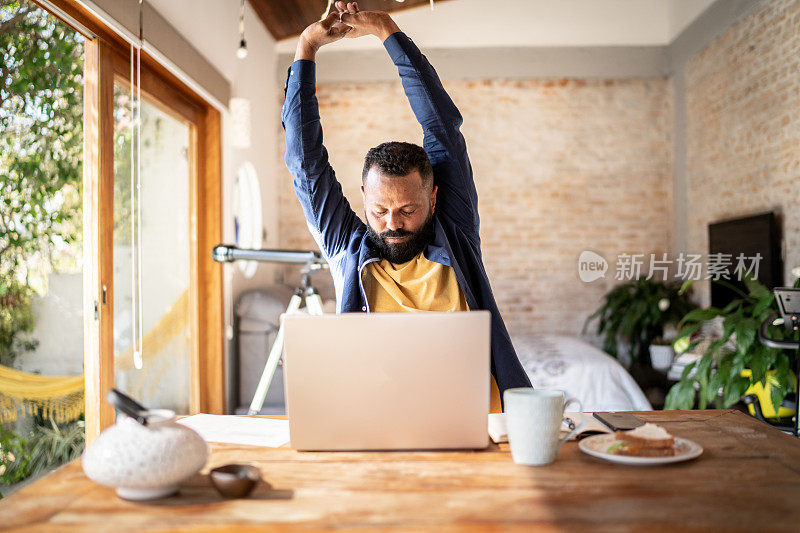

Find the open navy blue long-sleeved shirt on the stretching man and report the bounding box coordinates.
[281,32,531,399]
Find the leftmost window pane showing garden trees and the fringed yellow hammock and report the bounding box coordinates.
[0,0,84,486]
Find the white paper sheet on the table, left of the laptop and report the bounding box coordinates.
[178,413,289,448]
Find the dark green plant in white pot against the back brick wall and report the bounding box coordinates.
[583,278,695,361]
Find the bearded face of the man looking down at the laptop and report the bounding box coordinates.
[361,167,437,263]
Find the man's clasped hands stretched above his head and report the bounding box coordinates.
[295,2,400,61]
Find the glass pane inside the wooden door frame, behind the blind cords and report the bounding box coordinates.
[113,80,195,414]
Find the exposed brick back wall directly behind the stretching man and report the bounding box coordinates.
[279,79,673,334]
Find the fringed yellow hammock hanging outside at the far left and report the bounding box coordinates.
[0,365,84,422]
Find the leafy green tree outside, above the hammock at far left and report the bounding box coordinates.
[0,0,83,280]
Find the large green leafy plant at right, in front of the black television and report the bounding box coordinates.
[664,281,796,411]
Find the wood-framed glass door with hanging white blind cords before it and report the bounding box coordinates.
[72,5,225,436]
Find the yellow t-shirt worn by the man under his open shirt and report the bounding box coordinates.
[364,252,501,413]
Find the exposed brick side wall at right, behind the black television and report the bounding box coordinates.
[685,0,800,299]
